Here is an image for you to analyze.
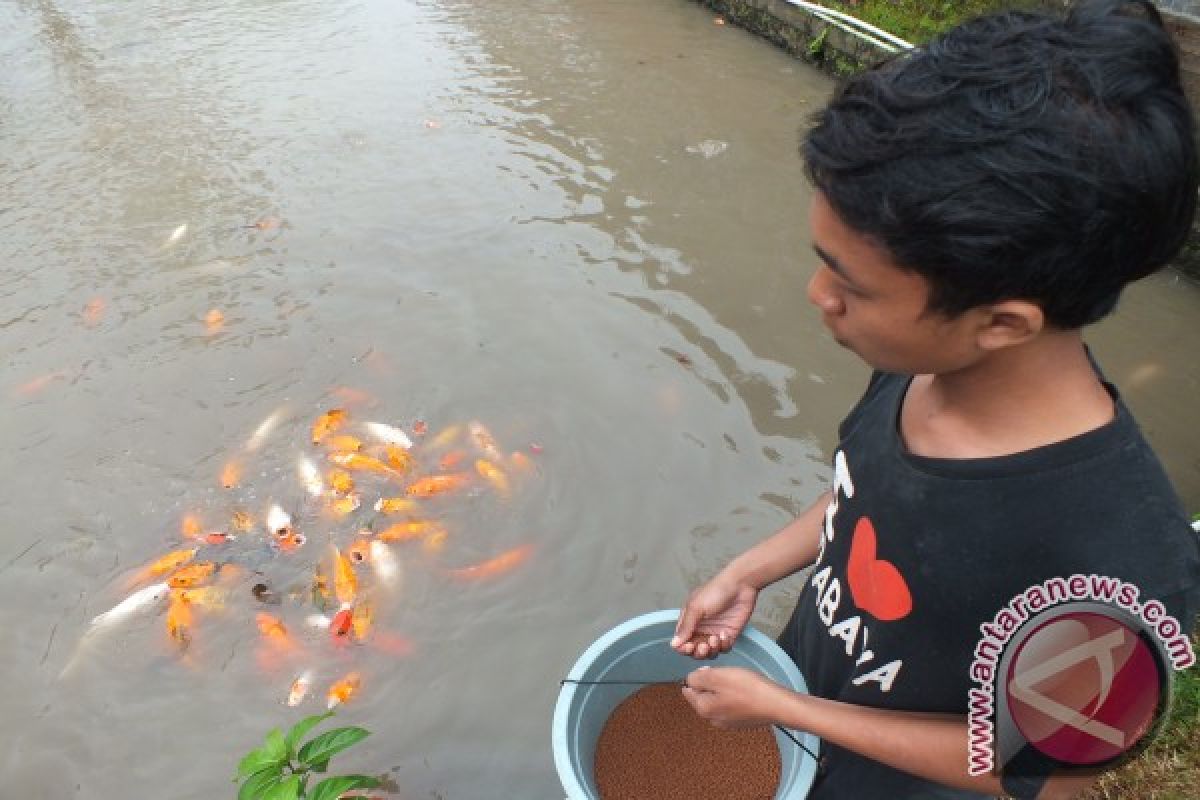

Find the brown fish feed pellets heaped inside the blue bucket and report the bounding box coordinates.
[595,684,782,800]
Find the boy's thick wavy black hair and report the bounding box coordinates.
[802,0,1198,329]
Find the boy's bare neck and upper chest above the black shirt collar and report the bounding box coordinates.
[900,331,1115,458]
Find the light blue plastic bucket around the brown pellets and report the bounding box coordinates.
[551,609,821,800]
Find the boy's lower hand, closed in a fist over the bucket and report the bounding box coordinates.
[683,667,787,728]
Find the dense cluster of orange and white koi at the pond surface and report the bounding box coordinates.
[62,408,541,709]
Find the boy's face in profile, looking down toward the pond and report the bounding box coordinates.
[808,192,983,375]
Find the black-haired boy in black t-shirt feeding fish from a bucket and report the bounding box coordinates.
[672,0,1200,799]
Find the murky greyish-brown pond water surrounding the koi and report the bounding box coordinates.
[0,0,1200,799]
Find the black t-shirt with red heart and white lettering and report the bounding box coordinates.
[780,373,1200,799]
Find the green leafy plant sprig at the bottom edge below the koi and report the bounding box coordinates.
[234,711,380,800]
